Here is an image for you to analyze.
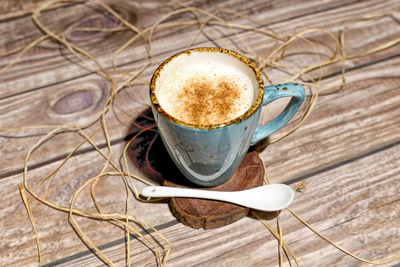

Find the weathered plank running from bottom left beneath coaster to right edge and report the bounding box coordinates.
[0,54,400,262]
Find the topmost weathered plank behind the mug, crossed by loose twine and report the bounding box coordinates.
[0,1,372,98]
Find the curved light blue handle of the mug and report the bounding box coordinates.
[251,83,305,145]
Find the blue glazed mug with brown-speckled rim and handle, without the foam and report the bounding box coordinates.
[150,48,305,186]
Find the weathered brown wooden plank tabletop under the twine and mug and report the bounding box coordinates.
[0,0,400,266]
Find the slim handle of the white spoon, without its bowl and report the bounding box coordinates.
[142,186,237,203]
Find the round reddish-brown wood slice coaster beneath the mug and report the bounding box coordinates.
[126,109,264,229]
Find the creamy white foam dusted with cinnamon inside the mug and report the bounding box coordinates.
[155,52,258,125]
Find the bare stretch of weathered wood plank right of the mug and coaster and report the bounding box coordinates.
[262,54,400,184]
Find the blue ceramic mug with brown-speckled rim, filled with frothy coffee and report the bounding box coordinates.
[150,47,305,186]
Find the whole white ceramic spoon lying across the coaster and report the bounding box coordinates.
[142,184,294,211]
